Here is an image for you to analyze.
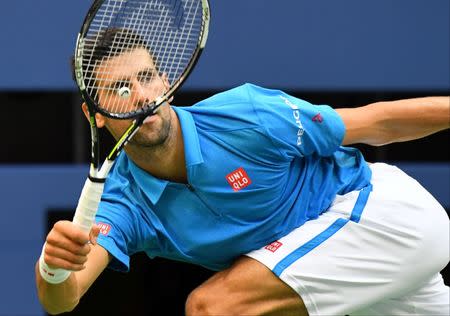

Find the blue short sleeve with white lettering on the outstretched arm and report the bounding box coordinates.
[247,84,345,158]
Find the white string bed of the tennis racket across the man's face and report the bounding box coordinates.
[83,0,202,114]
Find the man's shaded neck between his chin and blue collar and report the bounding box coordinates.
[125,110,187,183]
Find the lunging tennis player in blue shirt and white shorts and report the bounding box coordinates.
[36,28,450,315]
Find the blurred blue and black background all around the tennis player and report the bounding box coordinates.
[0,0,450,315]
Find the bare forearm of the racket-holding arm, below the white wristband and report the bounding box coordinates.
[35,262,80,314]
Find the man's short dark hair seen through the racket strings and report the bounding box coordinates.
[71,28,151,101]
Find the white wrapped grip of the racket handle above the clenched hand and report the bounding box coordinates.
[73,178,105,232]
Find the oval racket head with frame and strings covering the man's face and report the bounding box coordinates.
[74,0,210,119]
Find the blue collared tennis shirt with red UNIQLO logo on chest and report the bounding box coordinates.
[97,84,371,271]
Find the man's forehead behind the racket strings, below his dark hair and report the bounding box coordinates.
[95,48,155,85]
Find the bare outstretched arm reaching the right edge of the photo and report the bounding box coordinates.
[337,97,450,146]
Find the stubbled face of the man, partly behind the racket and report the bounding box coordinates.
[96,48,171,147]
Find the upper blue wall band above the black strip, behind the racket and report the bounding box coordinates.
[0,0,450,90]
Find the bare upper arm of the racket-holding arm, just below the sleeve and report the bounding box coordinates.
[74,244,112,297]
